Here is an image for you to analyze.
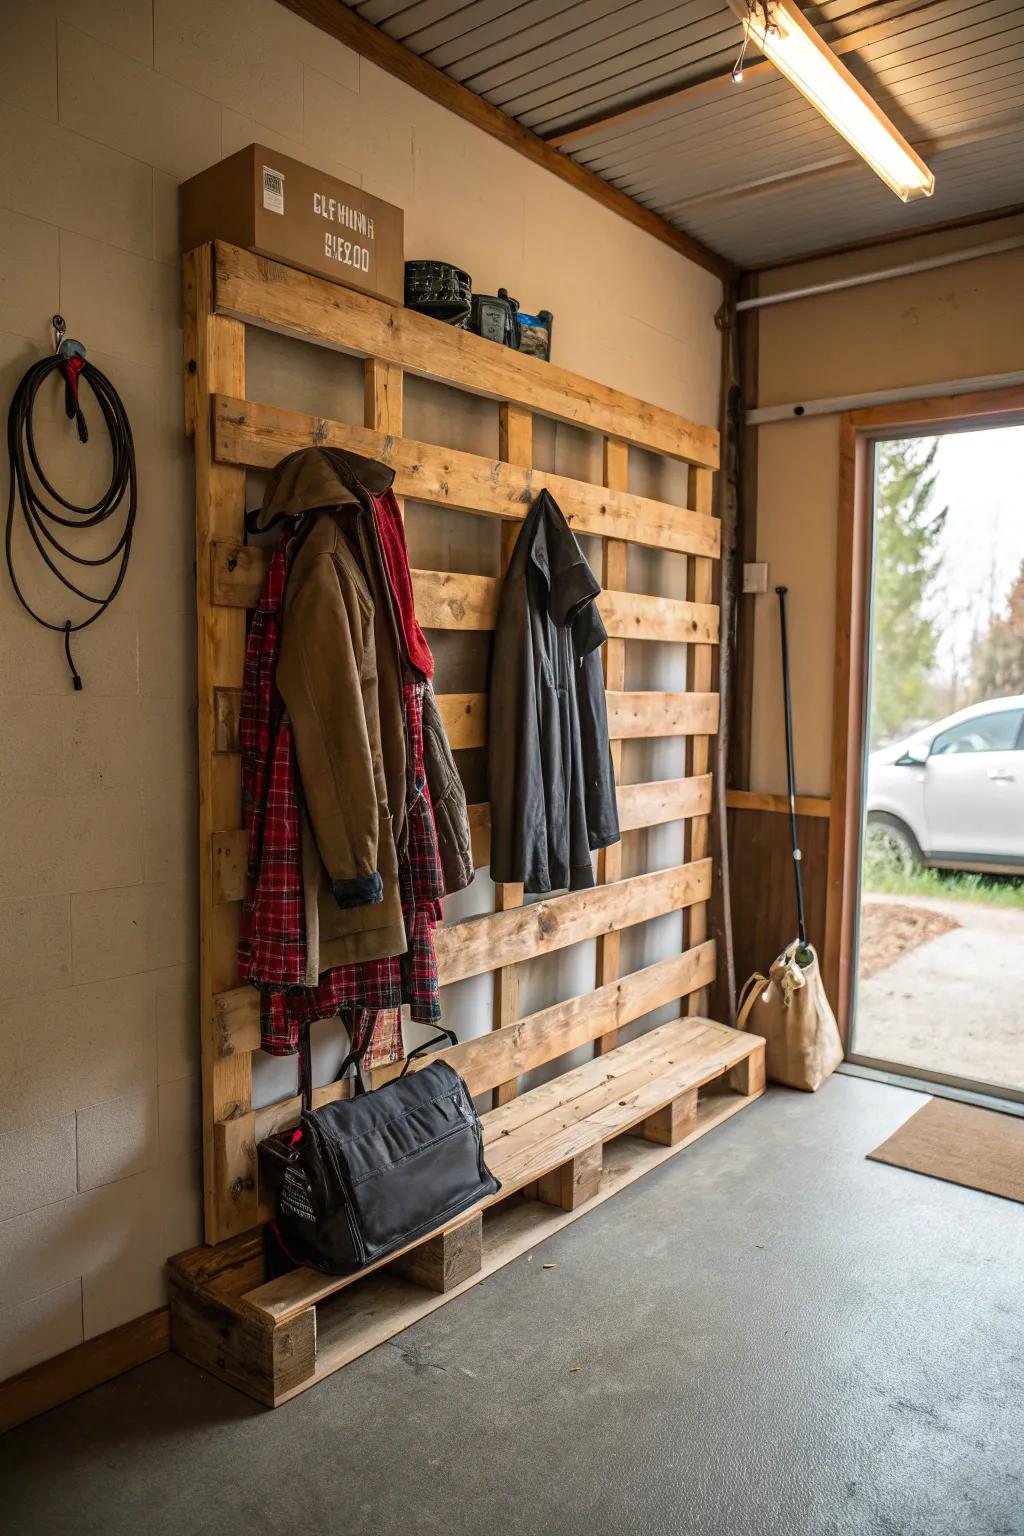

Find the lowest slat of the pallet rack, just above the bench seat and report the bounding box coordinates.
[372,940,715,1094]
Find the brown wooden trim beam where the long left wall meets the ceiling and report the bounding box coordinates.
[271,0,735,281]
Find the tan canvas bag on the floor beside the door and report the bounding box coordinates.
[735,940,843,1092]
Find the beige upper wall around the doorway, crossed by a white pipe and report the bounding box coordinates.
[751,218,1024,794]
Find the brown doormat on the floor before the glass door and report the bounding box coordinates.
[867,1098,1024,1204]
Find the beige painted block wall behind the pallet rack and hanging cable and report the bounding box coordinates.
[0,0,720,1376]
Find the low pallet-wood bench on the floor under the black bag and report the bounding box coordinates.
[172,1018,765,1402]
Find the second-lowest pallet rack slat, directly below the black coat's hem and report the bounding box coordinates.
[434,859,711,985]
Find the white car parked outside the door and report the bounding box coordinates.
[866,694,1024,874]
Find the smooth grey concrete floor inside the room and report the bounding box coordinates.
[0,1077,1024,1536]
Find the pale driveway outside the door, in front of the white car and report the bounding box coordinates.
[854,895,1024,1089]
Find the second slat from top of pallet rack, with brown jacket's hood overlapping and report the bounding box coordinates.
[212,395,720,556]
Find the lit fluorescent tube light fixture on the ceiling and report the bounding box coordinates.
[743,0,935,203]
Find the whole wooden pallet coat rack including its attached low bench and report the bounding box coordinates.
[170,243,763,1404]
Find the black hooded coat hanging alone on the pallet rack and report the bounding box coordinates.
[488,490,619,892]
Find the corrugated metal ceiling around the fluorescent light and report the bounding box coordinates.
[345,0,1024,267]
